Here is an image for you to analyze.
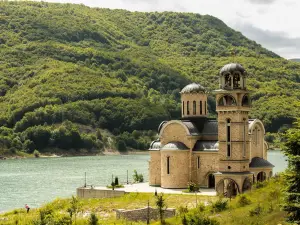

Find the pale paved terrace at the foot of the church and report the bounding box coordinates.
[94,182,216,196]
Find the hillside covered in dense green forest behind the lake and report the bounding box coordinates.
[0,1,300,153]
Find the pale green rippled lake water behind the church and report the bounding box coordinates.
[0,151,287,212]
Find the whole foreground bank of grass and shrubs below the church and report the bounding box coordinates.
[0,176,288,225]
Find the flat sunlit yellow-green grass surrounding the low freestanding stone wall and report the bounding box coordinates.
[0,193,216,225]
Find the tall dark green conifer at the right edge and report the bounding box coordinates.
[284,119,300,224]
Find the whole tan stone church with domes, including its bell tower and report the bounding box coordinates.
[149,63,274,196]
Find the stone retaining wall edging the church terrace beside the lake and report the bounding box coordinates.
[77,187,125,198]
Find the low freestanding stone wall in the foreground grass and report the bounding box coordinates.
[116,207,176,221]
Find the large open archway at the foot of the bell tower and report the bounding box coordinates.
[216,178,240,198]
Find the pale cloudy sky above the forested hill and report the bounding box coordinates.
[41,0,300,59]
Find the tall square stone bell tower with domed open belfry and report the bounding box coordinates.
[214,63,252,195]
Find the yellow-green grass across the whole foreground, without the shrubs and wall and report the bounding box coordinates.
[0,179,287,225]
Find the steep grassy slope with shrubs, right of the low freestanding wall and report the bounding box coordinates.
[162,177,289,225]
